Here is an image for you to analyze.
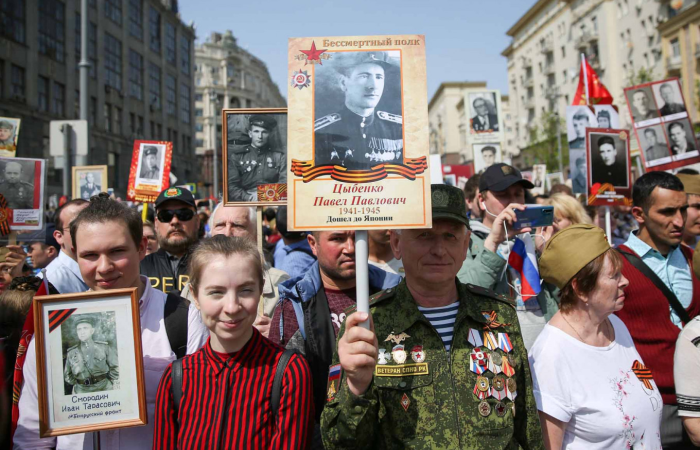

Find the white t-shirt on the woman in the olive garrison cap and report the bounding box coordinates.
[528,315,663,450]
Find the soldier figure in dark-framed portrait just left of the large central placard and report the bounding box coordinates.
[228,114,287,202]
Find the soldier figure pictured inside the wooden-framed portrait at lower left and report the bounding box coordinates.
[63,316,119,394]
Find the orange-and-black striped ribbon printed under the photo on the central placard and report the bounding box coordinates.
[292,156,428,183]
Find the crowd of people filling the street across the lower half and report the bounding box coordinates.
[0,163,700,450]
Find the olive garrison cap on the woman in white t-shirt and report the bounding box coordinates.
[539,223,611,289]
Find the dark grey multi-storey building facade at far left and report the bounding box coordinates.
[0,0,199,197]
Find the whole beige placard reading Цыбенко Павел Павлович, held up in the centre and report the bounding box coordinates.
[287,35,432,231]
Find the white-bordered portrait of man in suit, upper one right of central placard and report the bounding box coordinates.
[464,90,503,142]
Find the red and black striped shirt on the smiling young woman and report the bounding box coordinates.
[153,329,314,450]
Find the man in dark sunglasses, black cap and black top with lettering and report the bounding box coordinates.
[141,187,199,293]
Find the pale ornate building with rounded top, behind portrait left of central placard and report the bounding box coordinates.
[195,30,287,196]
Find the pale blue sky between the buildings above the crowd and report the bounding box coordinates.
[179,0,535,99]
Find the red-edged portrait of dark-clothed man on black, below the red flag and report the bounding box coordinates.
[586,128,632,205]
